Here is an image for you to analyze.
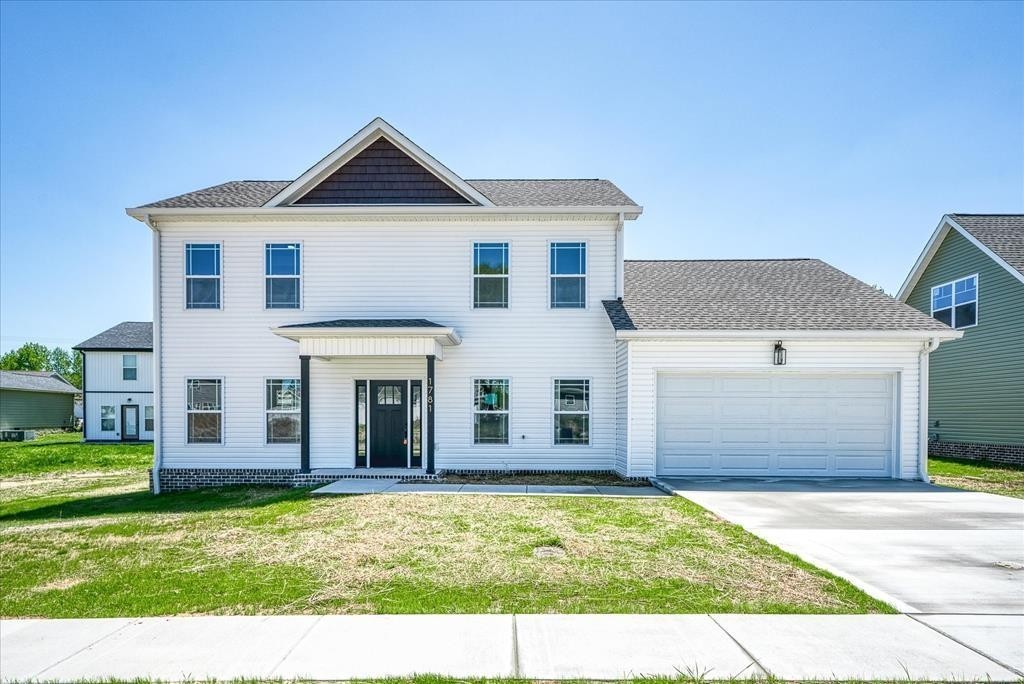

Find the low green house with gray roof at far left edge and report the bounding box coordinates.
[0,371,80,430]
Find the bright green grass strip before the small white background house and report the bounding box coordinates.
[0,432,153,477]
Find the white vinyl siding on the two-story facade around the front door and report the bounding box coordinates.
[153,217,615,470]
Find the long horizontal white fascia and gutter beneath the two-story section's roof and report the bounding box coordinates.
[125,205,643,222]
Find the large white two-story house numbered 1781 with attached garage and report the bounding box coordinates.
[125,119,957,488]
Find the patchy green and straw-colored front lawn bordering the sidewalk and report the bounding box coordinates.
[0,443,891,617]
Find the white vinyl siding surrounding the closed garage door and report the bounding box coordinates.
[628,339,922,479]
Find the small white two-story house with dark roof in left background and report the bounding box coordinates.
[74,320,156,441]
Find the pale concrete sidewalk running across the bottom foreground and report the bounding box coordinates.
[0,614,1024,682]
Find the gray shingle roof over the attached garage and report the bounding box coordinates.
[604,259,949,332]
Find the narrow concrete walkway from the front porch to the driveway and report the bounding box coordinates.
[310,478,669,498]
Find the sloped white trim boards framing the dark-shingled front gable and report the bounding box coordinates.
[263,117,494,207]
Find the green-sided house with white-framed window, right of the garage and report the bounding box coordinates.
[899,214,1024,463]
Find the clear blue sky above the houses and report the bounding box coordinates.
[0,2,1024,349]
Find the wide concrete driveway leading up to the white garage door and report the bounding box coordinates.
[658,478,1024,614]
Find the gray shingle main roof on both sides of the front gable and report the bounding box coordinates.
[136,178,636,209]
